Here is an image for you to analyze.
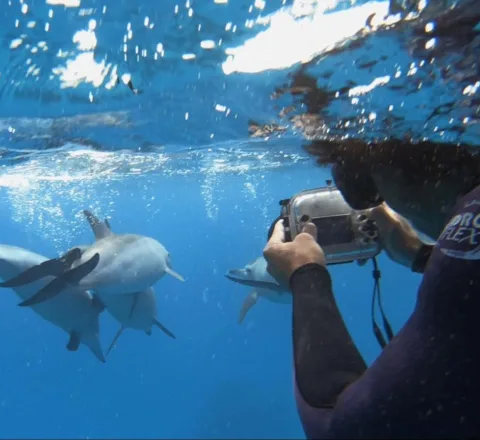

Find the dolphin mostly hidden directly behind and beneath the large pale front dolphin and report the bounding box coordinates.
[80,210,176,356]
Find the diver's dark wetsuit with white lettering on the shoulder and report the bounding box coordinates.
[290,187,480,439]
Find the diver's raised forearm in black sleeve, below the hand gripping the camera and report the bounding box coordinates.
[290,264,367,437]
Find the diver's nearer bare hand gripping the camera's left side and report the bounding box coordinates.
[263,220,326,288]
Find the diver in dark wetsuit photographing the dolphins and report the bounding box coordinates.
[264,141,480,439]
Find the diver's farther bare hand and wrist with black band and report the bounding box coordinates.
[370,202,433,273]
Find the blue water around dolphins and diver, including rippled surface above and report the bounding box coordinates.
[0,0,478,438]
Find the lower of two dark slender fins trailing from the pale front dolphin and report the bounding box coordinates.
[19,253,100,307]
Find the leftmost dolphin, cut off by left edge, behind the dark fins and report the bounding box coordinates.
[0,244,105,362]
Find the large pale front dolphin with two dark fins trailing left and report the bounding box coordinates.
[0,211,184,306]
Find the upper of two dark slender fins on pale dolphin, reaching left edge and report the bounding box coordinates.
[0,248,82,287]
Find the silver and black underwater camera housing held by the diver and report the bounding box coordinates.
[280,186,381,264]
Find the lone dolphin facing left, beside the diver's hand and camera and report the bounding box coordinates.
[225,257,292,324]
